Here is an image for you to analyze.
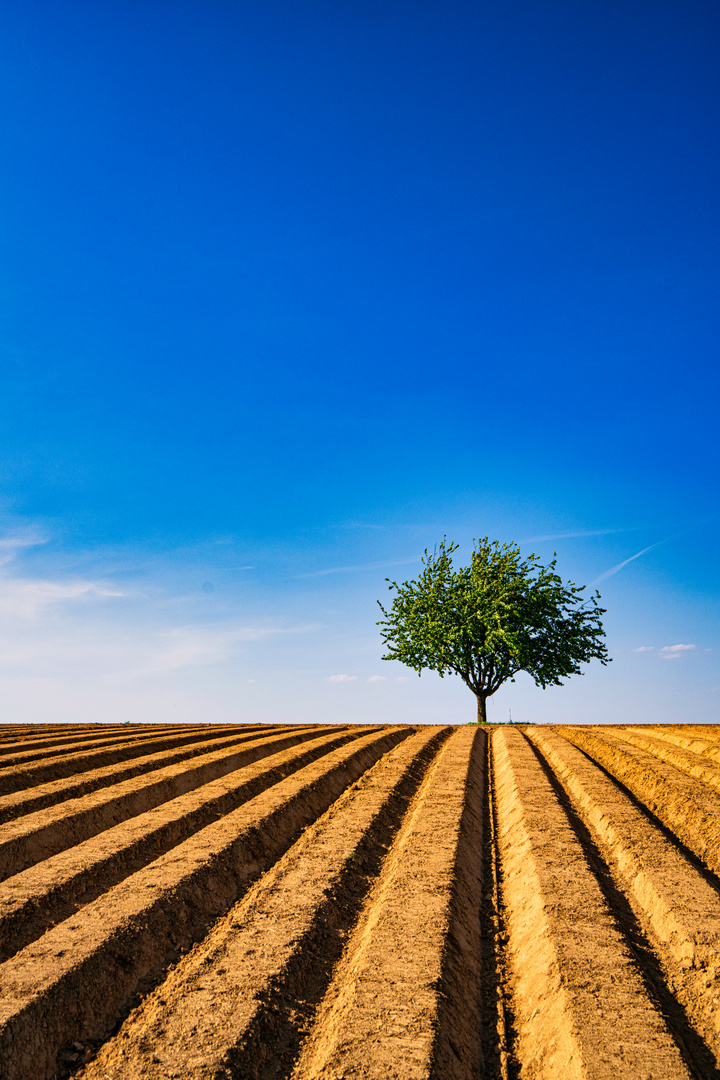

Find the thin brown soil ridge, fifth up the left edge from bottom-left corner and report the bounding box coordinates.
[0,725,263,806]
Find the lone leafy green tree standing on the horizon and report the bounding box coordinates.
[378,537,609,724]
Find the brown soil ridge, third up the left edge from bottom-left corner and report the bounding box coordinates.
[0,732,330,881]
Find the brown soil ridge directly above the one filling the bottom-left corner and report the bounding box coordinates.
[0,728,358,961]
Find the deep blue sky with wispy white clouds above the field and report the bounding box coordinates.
[0,0,720,723]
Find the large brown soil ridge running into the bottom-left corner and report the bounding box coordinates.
[0,728,412,1080]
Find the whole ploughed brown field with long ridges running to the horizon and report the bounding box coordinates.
[0,725,720,1080]
